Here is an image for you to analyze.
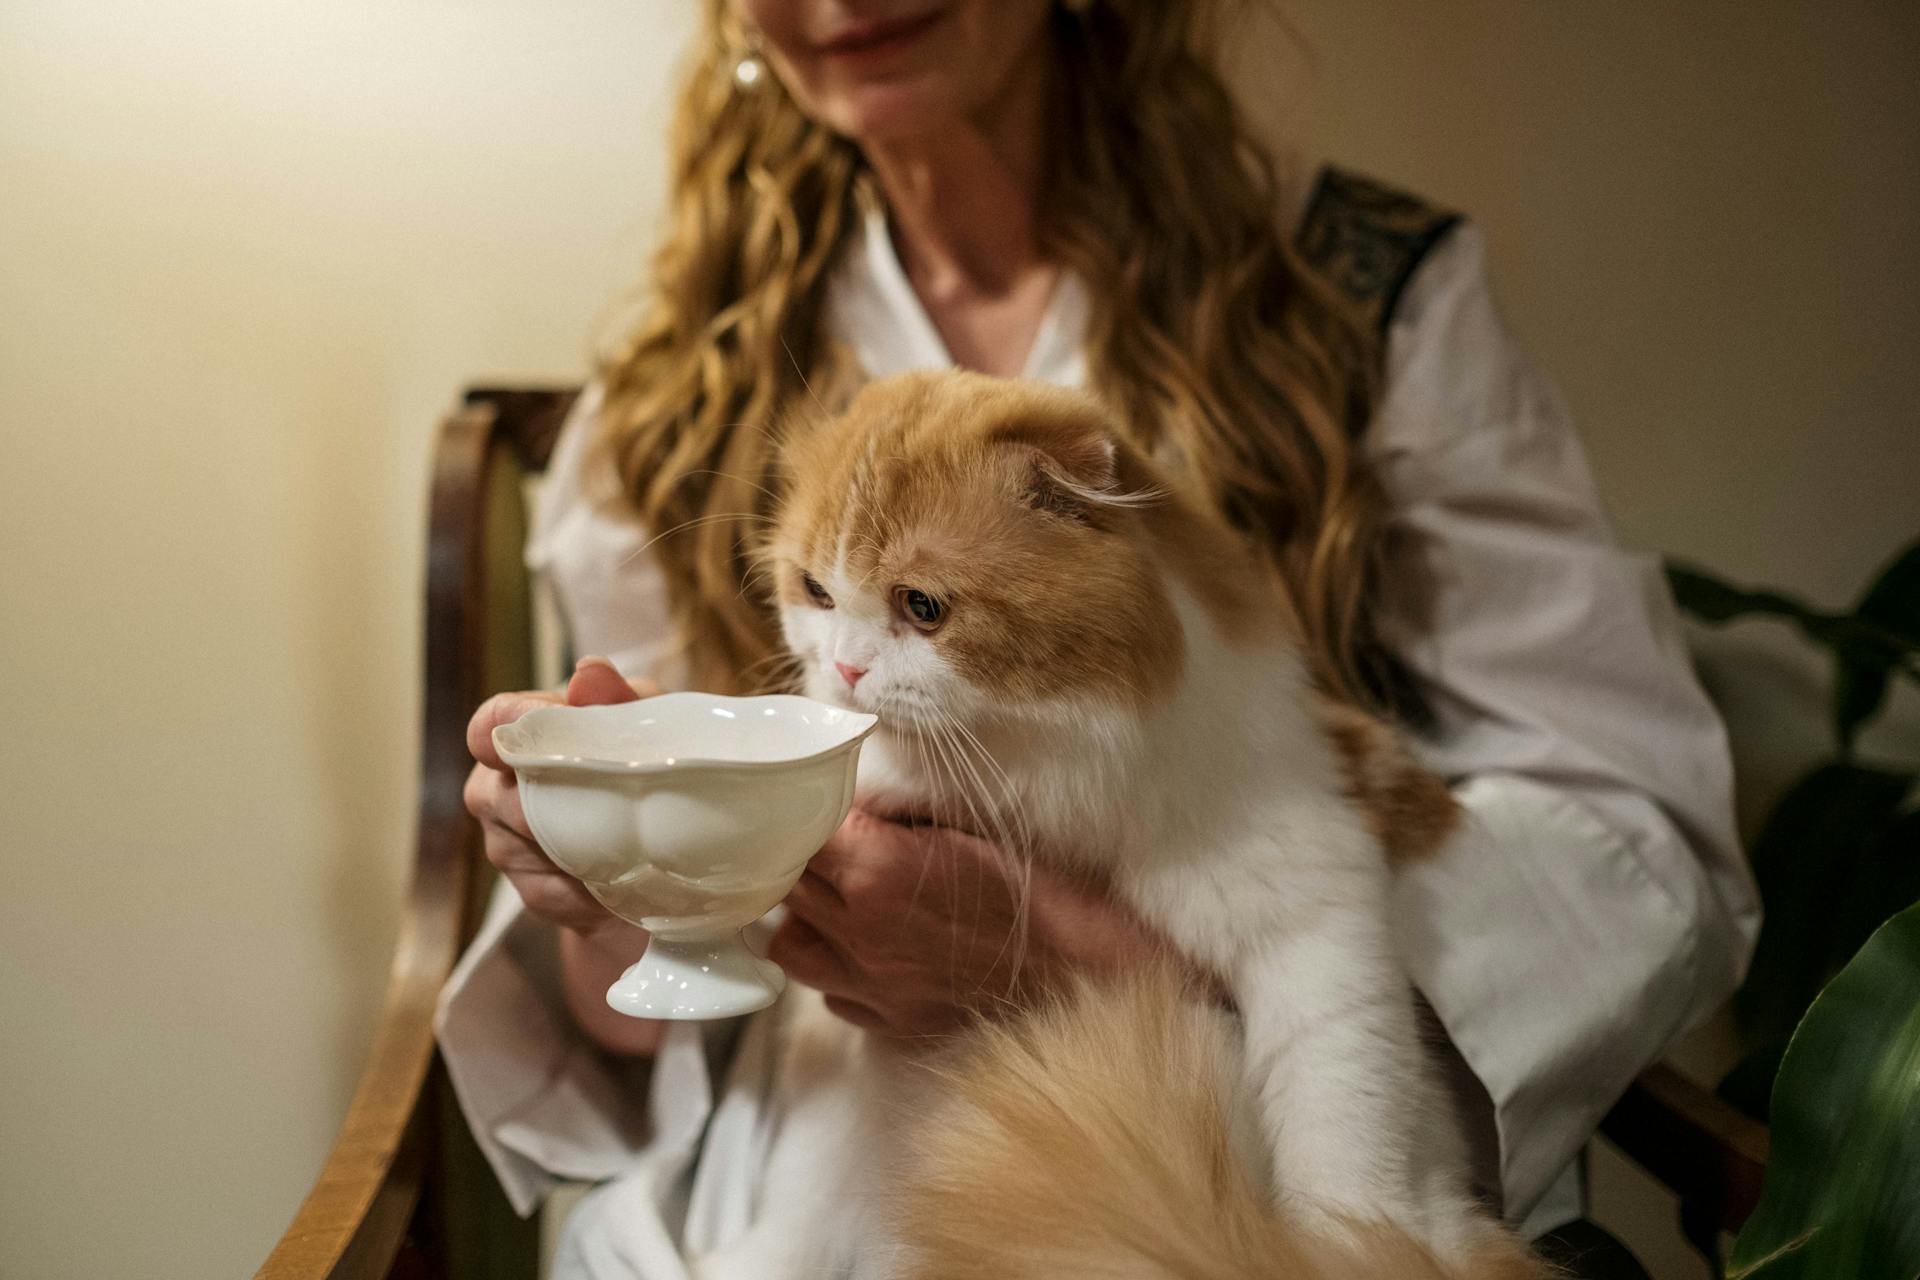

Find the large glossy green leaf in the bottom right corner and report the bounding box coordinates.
[1728,906,1920,1280]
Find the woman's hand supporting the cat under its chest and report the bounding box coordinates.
[768,810,1171,1036]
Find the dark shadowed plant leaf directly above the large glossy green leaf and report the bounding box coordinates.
[1734,764,1914,1048]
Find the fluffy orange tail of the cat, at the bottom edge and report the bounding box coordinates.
[897,971,1548,1280]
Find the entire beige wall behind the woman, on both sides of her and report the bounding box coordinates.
[0,0,1920,1278]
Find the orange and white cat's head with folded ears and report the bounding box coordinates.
[766,372,1185,727]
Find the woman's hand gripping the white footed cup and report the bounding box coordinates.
[465,658,660,1054]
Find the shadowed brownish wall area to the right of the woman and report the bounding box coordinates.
[1259,0,1920,603]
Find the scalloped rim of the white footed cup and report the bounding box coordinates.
[493,693,879,773]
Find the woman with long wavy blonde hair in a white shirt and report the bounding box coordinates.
[442,0,1757,1276]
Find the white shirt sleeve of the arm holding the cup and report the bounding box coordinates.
[434,386,708,1213]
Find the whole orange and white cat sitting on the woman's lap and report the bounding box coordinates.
[710,372,1532,1276]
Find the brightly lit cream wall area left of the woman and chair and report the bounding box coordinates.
[0,0,680,1280]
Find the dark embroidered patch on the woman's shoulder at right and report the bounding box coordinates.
[1294,165,1459,332]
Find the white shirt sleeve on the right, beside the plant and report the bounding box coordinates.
[1369,225,1759,1219]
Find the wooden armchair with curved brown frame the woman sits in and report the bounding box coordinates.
[257,388,1766,1280]
